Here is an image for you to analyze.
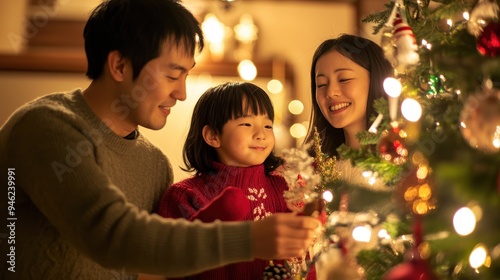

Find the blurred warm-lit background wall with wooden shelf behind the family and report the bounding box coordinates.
[0,0,388,181]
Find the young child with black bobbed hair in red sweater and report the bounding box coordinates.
[158,83,290,279]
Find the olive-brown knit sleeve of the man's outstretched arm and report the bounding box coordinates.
[0,106,252,279]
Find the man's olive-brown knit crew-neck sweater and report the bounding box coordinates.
[0,89,252,279]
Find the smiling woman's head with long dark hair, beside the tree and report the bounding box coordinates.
[306,34,394,156]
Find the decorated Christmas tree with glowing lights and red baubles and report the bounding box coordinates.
[308,0,500,280]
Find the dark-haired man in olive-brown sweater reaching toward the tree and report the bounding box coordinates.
[0,0,318,279]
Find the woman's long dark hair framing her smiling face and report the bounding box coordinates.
[305,34,394,156]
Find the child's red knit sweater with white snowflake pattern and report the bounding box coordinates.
[158,163,290,280]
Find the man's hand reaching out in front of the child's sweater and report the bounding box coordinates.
[252,213,320,260]
